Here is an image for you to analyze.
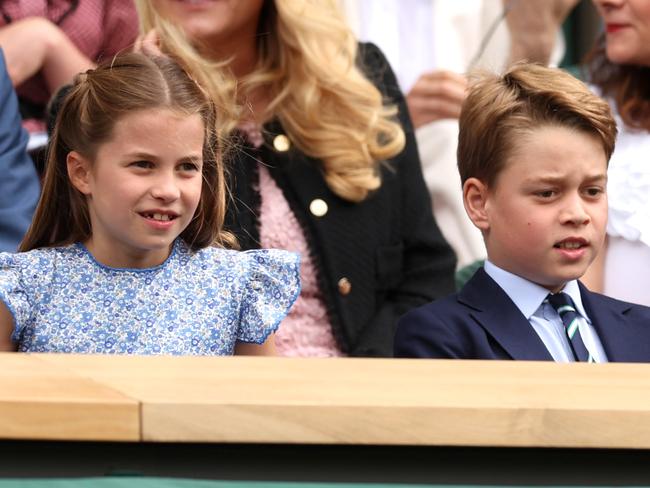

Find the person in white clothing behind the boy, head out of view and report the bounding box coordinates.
[339,0,578,266]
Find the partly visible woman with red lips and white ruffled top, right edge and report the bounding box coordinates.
[585,0,650,305]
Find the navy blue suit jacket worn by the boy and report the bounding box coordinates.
[395,268,650,362]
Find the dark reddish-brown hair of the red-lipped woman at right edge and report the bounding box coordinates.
[586,34,650,131]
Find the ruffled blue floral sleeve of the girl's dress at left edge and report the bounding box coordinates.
[0,253,32,342]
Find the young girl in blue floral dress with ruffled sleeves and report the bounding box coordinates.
[0,54,300,355]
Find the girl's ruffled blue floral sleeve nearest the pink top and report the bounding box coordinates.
[237,249,300,344]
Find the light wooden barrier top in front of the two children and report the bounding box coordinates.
[0,354,650,448]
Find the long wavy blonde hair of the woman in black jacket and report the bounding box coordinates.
[136,0,405,202]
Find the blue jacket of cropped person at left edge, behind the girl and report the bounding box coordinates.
[0,50,40,251]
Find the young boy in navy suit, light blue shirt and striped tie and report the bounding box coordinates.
[395,64,650,362]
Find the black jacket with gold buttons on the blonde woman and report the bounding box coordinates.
[227,44,455,356]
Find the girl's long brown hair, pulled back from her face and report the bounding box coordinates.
[20,53,234,251]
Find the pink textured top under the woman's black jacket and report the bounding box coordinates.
[240,125,343,357]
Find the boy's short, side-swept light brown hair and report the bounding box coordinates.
[457,63,616,187]
